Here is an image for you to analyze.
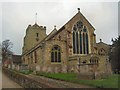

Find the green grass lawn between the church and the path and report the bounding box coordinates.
[37,73,120,88]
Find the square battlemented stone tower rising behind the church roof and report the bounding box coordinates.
[22,23,47,54]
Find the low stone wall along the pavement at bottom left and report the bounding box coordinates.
[3,68,52,88]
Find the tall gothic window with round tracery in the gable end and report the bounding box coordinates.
[73,21,89,54]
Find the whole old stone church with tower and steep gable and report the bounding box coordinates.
[22,8,111,74]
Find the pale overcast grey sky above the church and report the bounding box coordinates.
[0,0,118,54]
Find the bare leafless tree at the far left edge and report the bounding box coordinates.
[2,40,13,63]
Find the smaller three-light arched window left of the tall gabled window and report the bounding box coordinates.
[51,45,61,62]
